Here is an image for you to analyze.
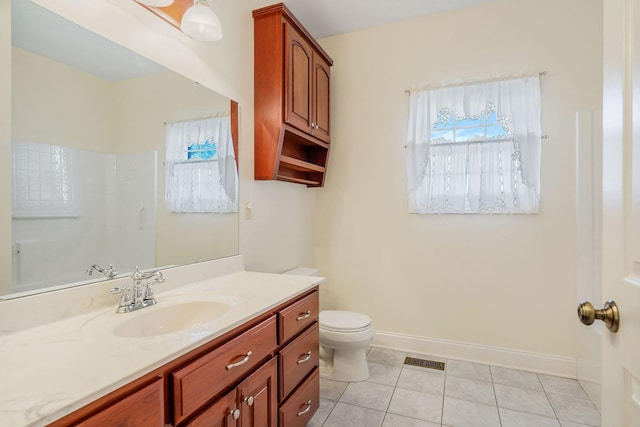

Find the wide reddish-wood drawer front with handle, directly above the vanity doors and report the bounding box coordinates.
[171,316,276,423]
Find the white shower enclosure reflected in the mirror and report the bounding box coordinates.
[12,145,157,292]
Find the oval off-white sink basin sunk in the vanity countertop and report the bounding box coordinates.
[113,301,229,338]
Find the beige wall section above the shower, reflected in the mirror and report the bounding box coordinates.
[11,48,115,153]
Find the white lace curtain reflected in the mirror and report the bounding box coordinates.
[165,114,238,213]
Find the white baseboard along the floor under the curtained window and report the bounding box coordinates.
[371,331,577,378]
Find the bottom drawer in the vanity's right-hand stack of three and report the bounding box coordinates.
[280,369,320,427]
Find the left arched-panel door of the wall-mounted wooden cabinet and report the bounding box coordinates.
[284,24,313,134]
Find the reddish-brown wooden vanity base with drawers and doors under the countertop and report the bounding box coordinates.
[50,287,320,427]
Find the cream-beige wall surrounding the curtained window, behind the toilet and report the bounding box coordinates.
[315,0,602,358]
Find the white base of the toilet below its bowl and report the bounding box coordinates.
[320,348,369,382]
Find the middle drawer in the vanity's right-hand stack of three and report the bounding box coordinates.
[279,322,320,401]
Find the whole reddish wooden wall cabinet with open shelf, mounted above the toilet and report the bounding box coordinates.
[253,3,333,187]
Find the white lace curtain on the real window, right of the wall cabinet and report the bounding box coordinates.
[407,75,541,214]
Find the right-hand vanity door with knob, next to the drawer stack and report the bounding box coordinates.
[238,357,278,427]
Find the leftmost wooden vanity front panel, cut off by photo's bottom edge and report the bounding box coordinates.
[75,379,164,427]
